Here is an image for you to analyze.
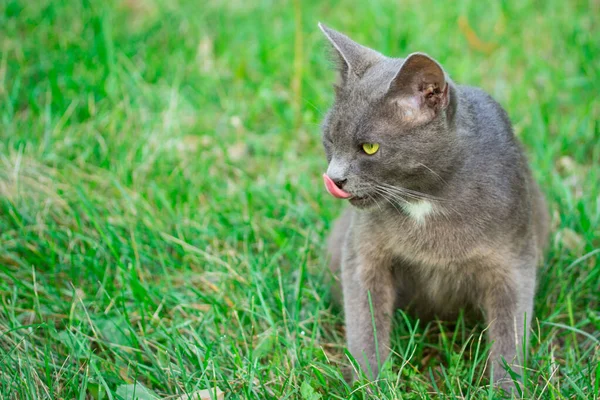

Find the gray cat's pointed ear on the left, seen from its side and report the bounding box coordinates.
[319,22,381,84]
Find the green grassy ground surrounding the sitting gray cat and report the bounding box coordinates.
[0,0,600,400]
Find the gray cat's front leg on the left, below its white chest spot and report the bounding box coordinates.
[342,251,396,379]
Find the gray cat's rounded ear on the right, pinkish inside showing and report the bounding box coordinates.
[387,53,450,123]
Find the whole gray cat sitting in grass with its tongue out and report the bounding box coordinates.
[319,25,548,388]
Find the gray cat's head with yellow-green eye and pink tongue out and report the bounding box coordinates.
[319,24,456,208]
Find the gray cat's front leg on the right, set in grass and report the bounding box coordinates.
[483,263,536,392]
